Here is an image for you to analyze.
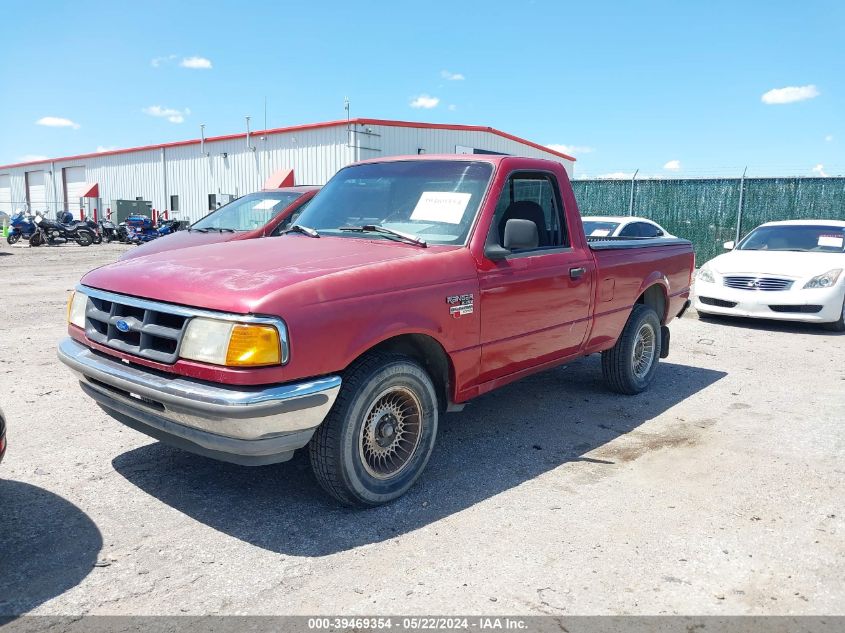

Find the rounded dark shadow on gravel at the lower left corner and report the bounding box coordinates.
[0,479,103,612]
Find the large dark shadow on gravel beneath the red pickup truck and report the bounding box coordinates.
[112,357,725,556]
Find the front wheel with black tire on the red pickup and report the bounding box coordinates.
[309,353,439,507]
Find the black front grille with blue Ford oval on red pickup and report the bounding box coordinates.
[85,295,189,364]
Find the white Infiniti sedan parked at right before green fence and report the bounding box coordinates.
[695,220,845,332]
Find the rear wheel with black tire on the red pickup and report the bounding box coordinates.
[601,304,662,395]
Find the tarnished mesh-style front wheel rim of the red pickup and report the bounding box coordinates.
[358,387,423,479]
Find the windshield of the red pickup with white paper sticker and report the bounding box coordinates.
[297,160,493,244]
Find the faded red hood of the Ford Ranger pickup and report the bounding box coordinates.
[82,235,459,314]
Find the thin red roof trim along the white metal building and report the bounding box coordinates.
[0,119,576,169]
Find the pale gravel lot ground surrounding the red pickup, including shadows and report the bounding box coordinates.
[0,244,845,614]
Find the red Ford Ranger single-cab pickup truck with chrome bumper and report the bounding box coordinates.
[59,155,694,506]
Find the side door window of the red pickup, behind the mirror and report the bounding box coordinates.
[488,172,569,249]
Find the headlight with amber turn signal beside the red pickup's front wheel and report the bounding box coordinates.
[179,317,287,367]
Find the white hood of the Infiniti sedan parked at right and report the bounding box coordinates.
[710,251,845,278]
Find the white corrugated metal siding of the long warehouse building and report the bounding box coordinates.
[4,125,571,221]
